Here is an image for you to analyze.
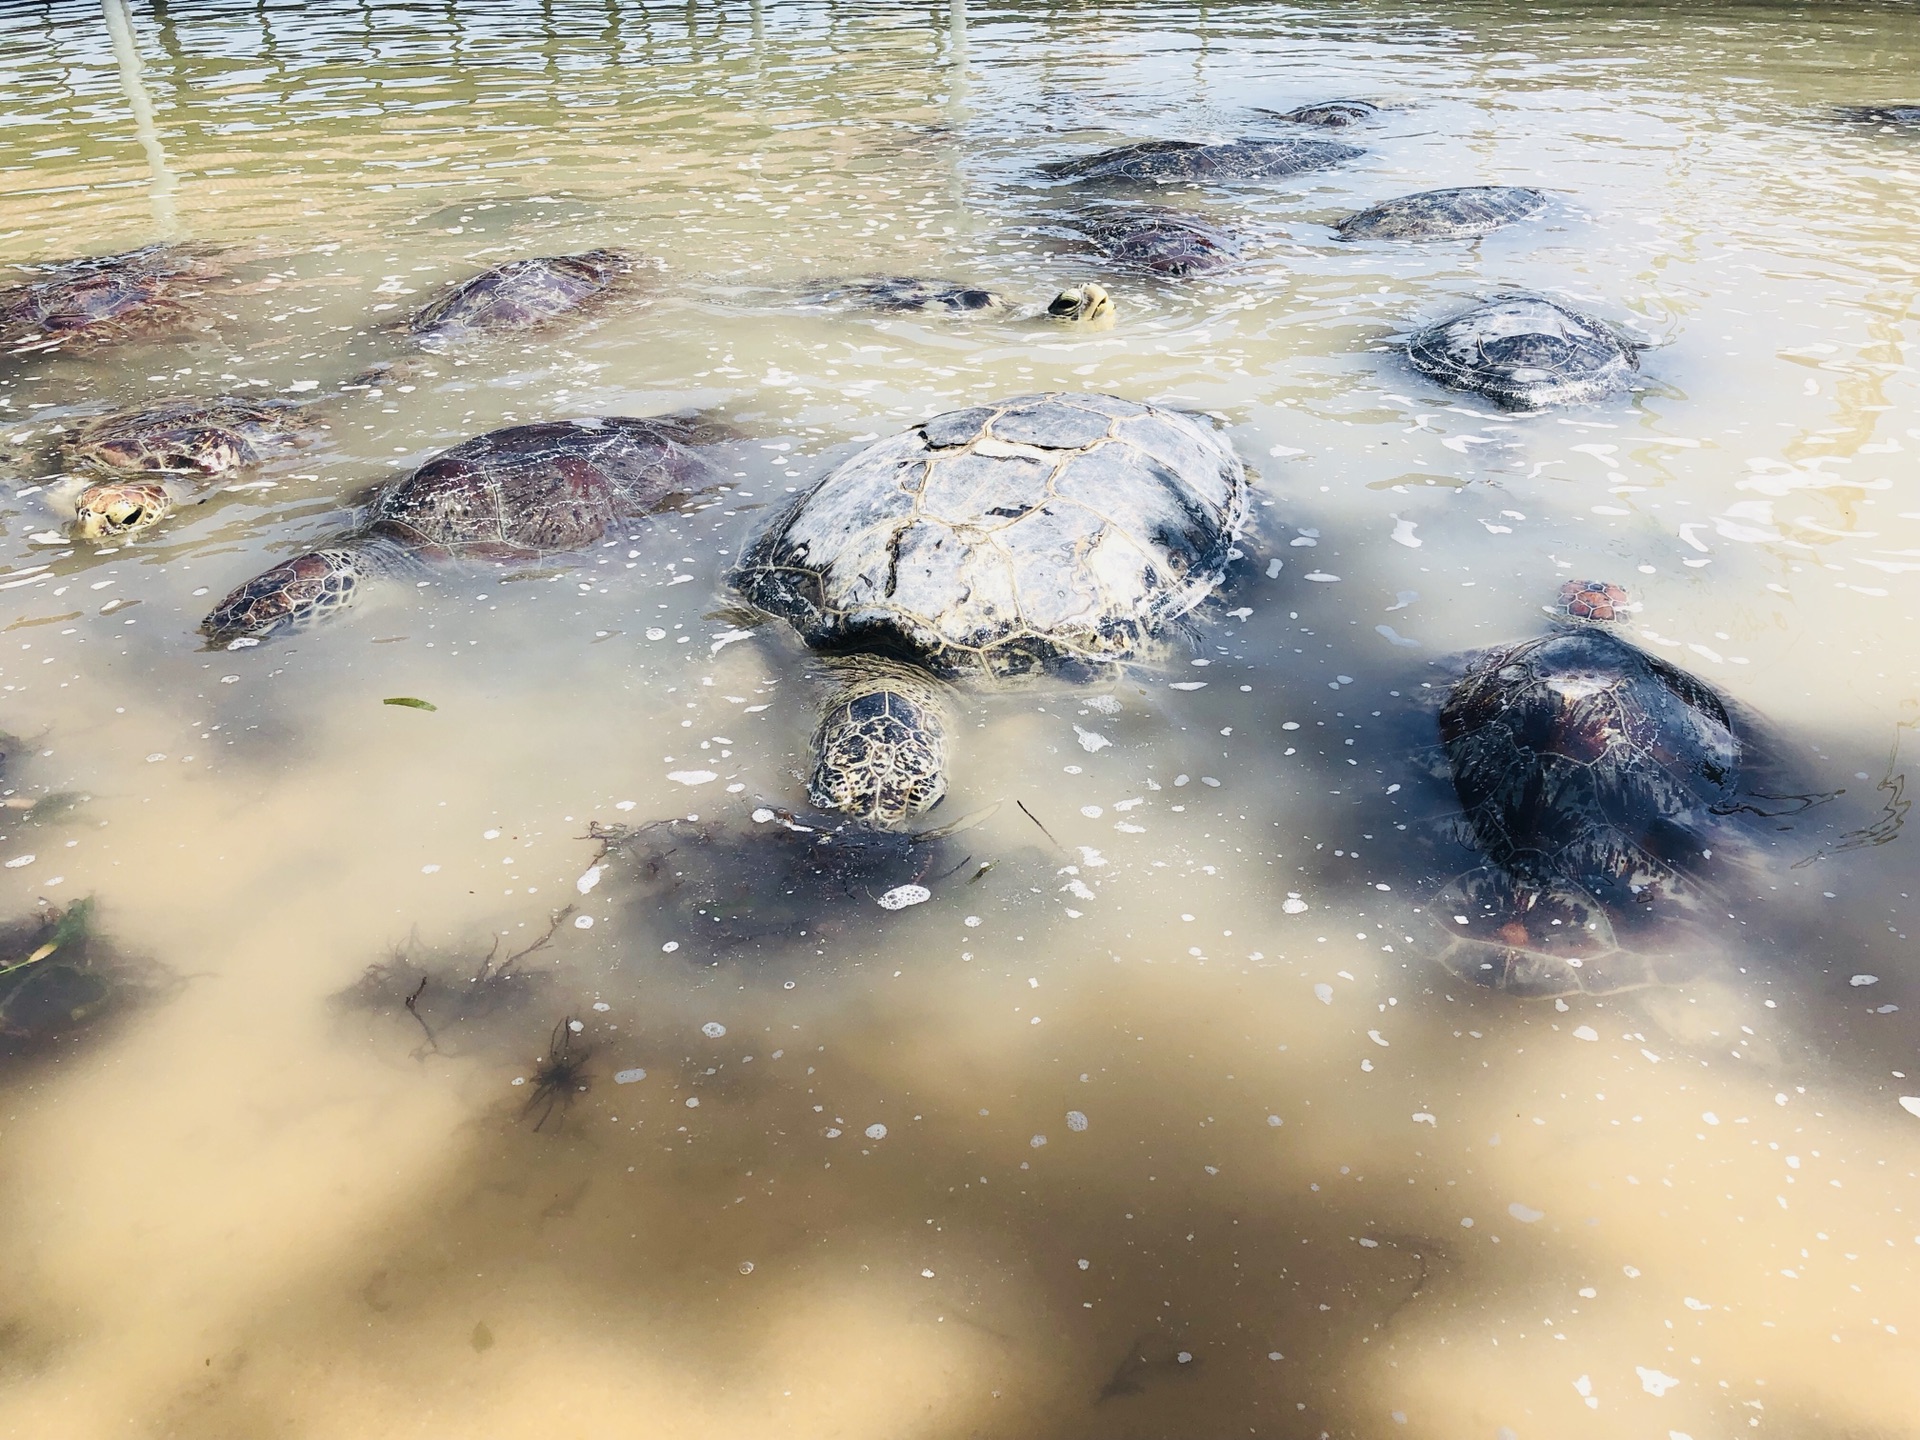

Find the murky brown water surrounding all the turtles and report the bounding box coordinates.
[0,0,1920,1440]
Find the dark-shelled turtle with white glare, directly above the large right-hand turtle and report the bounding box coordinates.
[1407,294,1644,409]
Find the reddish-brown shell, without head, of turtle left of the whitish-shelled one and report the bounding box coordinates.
[369,417,720,559]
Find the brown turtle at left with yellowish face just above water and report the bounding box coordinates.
[61,396,319,540]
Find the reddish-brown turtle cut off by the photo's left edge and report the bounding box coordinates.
[0,244,219,351]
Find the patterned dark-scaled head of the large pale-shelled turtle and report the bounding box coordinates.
[806,666,947,828]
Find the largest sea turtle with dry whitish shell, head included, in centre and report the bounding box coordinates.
[732,394,1246,826]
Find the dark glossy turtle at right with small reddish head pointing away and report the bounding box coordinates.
[1434,580,1749,995]
